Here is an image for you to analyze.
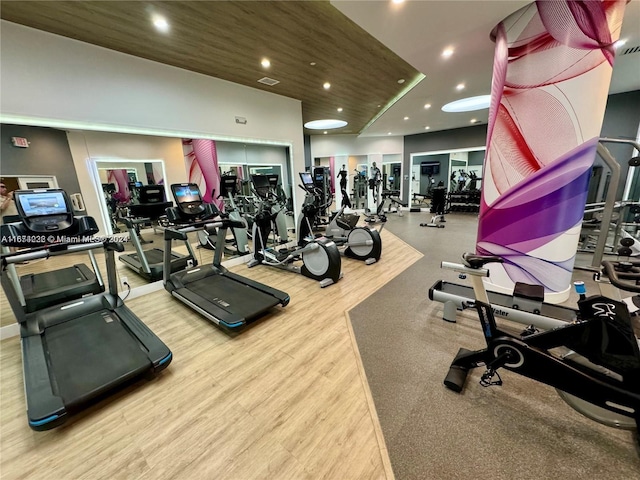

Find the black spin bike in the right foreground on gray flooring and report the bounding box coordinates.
[442,253,640,448]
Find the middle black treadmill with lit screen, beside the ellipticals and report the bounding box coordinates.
[164,183,290,332]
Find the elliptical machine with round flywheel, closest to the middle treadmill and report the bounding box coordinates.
[248,175,342,288]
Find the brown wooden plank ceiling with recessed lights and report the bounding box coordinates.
[0,1,419,134]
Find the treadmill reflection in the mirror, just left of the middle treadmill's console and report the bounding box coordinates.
[118,185,195,282]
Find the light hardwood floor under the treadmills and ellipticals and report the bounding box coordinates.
[0,230,421,480]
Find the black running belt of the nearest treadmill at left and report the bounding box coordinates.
[44,310,150,407]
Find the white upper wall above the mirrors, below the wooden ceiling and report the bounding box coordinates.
[0,21,304,218]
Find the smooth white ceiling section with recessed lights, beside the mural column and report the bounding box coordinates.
[331,0,640,137]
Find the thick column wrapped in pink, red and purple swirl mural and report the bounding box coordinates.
[476,0,627,302]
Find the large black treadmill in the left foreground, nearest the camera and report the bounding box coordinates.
[0,189,172,431]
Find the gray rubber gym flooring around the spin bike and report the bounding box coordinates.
[350,212,640,480]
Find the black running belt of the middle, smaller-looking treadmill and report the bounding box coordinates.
[188,275,280,321]
